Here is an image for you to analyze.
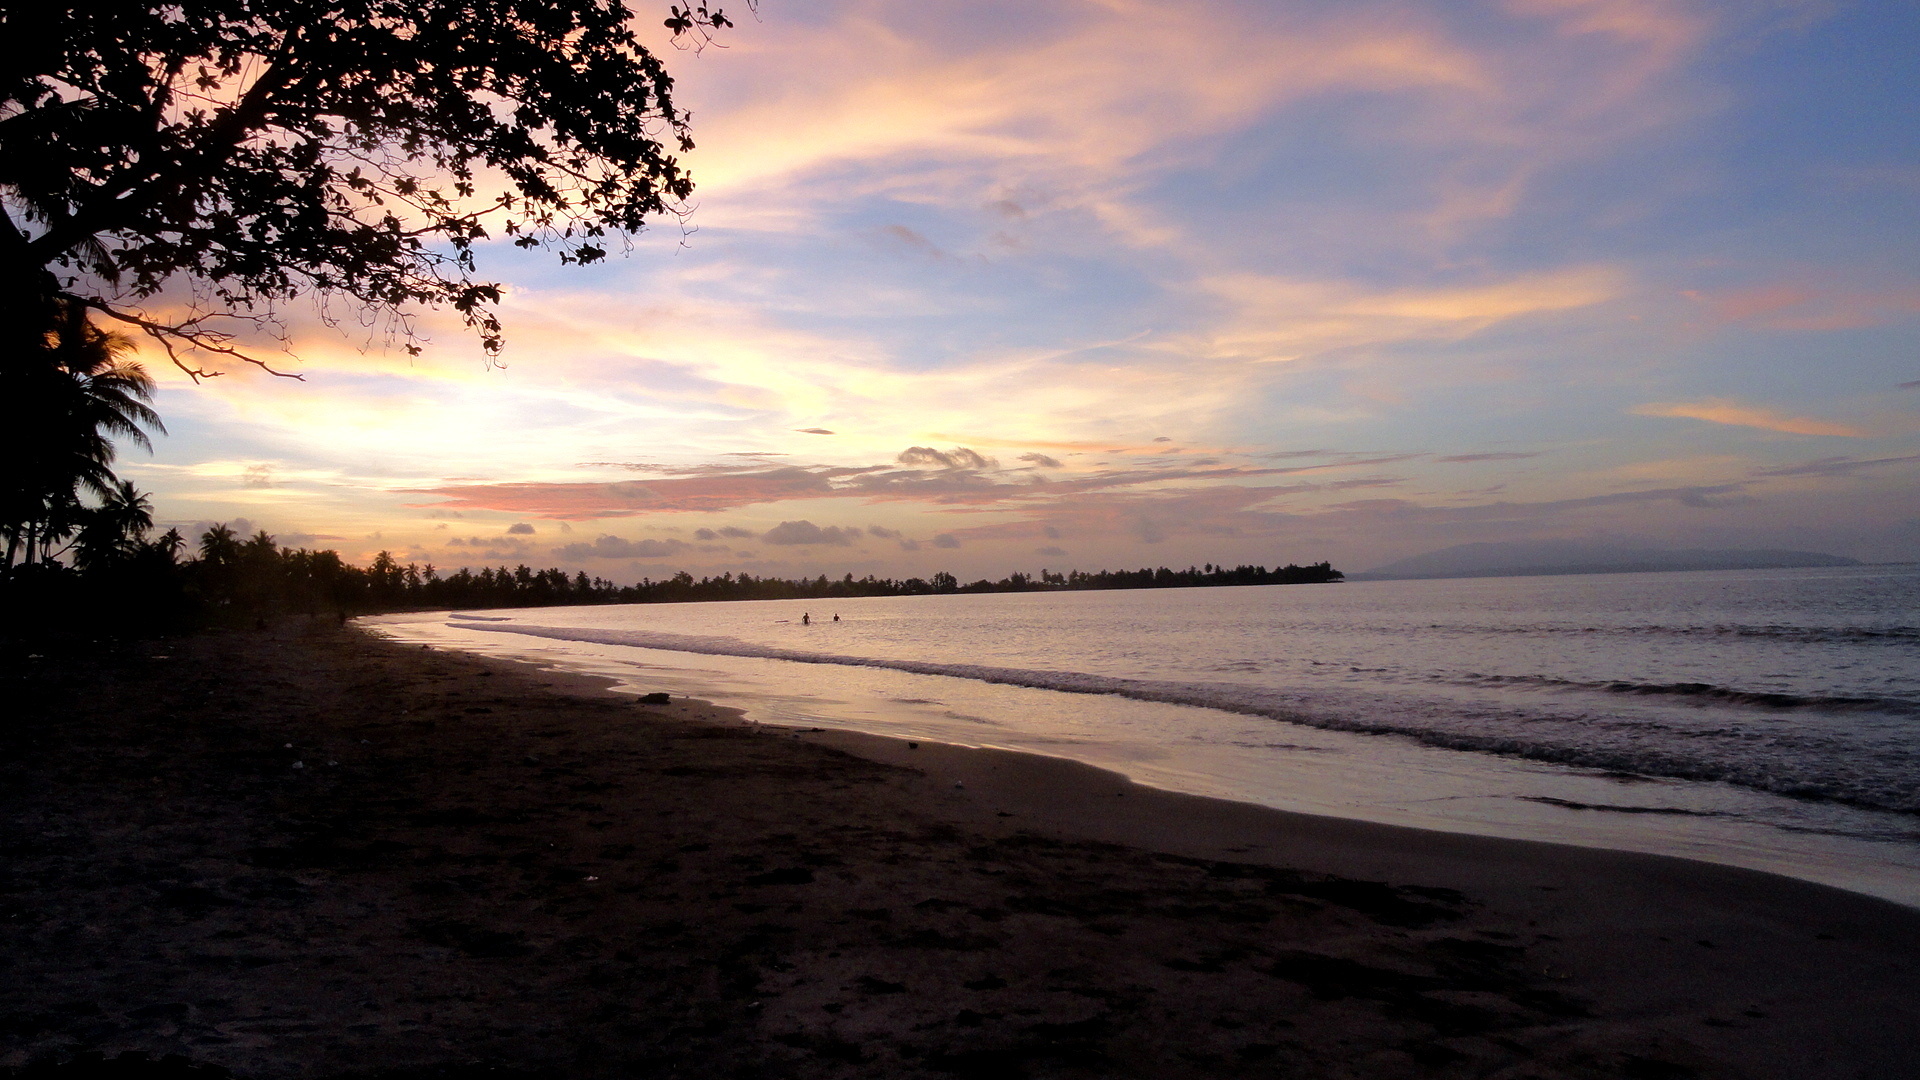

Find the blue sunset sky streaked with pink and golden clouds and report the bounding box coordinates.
[121,0,1920,582]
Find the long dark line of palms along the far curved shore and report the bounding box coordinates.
[0,515,1342,625]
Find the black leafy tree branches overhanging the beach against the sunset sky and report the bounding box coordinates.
[0,0,730,377]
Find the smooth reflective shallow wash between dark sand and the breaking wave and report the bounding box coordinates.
[372,617,1920,911]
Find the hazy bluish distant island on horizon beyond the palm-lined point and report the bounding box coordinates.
[1346,540,1860,580]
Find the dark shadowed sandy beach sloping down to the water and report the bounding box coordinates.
[0,626,1920,1080]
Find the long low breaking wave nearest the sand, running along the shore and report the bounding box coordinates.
[457,623,1920,815]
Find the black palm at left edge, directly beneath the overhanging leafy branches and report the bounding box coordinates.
[0,304,167,569]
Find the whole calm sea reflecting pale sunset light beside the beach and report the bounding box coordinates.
[369,567,1920,905]
